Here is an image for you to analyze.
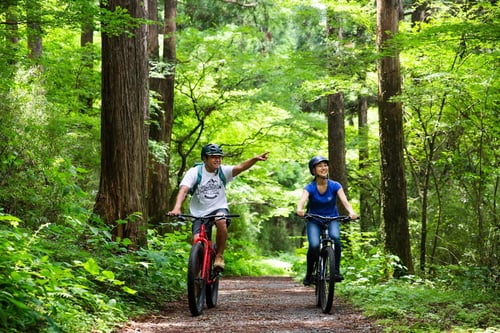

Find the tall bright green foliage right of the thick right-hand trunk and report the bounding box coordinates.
[398,3,500,267]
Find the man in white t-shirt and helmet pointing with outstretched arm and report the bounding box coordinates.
[168,143,269,271]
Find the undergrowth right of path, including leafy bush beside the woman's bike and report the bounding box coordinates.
[336,228,500,333]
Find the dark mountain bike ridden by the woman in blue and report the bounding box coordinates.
[304,214,351,313]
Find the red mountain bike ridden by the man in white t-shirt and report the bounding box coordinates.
[177,214,239,316]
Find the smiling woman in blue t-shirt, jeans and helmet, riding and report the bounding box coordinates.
[297,156,358,286]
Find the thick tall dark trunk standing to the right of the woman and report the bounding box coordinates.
[377,0,413,275]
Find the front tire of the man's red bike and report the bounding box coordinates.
[187,243,206,316]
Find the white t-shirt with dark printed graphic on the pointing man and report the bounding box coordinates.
[179,165,234,216]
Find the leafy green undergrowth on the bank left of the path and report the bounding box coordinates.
[0,214,189,332]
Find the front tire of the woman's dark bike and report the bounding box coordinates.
[320,246,335,313]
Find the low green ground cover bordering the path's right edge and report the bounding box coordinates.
[339,266,500,333]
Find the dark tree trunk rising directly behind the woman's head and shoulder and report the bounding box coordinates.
[327,92,347,214]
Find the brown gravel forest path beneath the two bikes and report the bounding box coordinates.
[116,277,383,333]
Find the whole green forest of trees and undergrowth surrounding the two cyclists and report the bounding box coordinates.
[0,0,500,332]
